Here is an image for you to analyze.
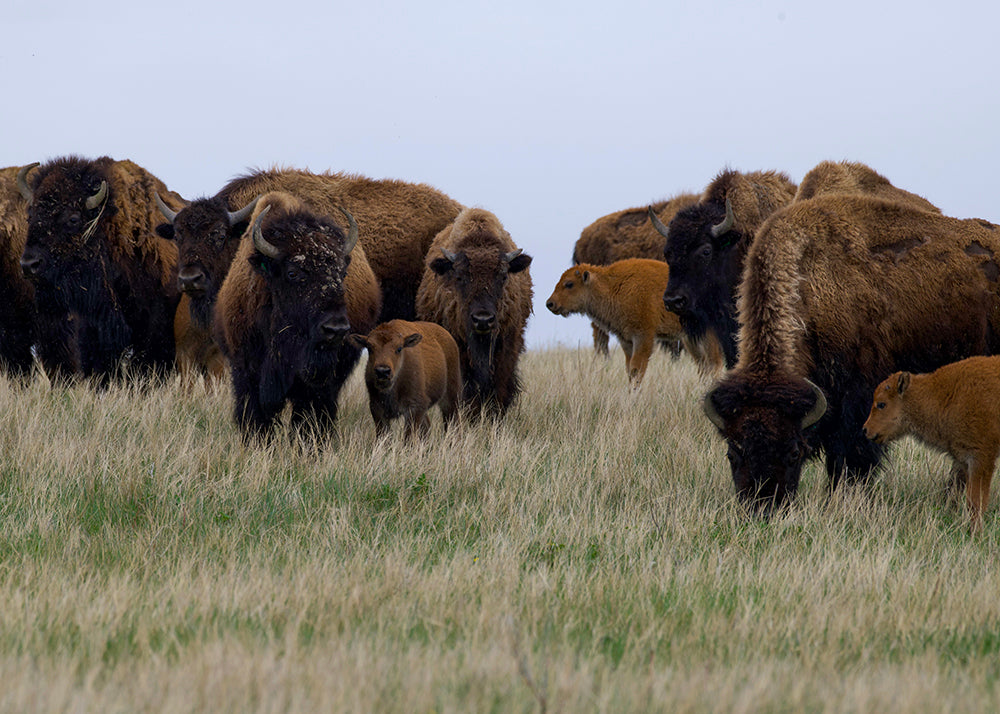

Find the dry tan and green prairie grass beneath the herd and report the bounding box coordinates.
[0,348,1000,712]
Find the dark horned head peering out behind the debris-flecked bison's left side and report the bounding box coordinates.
[156,195,259,329]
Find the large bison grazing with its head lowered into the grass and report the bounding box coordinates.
[703,195,1000,504]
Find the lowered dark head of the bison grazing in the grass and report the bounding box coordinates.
[703,374,826,515]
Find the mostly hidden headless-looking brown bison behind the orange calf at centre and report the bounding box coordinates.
[573,193,698,355]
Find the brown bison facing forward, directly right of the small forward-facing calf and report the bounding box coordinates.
[417,208,532,417]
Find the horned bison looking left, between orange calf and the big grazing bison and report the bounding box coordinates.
[649,170,796,367]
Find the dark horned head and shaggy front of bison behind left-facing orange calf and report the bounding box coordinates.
[649,200,742,367]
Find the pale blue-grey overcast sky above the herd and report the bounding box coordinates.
[0,0,1000,347]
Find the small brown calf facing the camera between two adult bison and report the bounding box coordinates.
[348,320,462,439]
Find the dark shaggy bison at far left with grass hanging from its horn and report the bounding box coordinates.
[19,156,182,379]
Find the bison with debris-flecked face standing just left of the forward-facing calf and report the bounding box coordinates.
[214,192,381,440]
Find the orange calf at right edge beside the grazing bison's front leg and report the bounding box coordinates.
[864,357,1000,530]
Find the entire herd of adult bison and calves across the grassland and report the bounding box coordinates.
[0,156,1000,527]
